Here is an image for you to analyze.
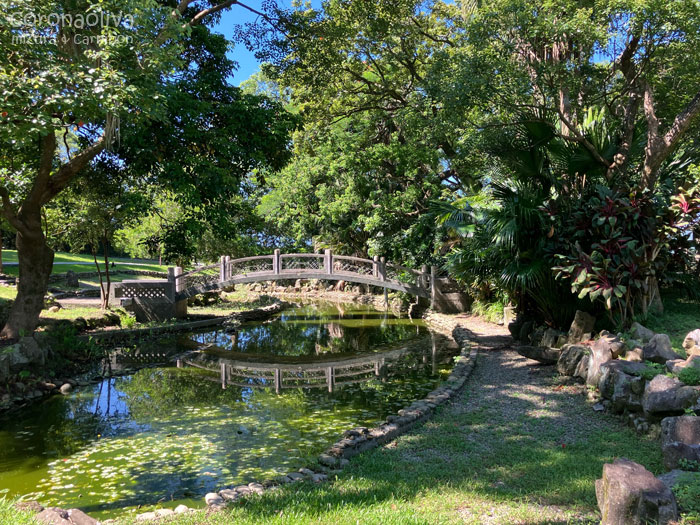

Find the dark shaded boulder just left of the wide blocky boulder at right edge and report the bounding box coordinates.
[598,359,646,413]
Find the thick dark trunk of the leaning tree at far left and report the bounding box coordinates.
[0,208,54,339]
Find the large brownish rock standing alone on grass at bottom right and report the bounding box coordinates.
[595,459,678,525]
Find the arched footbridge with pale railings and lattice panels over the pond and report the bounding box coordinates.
[113,250,465,320]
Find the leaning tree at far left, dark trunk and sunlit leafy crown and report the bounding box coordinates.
[0,0,296,338]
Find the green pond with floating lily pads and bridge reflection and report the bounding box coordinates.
[0,303,457,518]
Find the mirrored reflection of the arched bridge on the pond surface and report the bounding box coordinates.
[177,334,456,393]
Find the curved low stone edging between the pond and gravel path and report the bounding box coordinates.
[194,311,480,521]
